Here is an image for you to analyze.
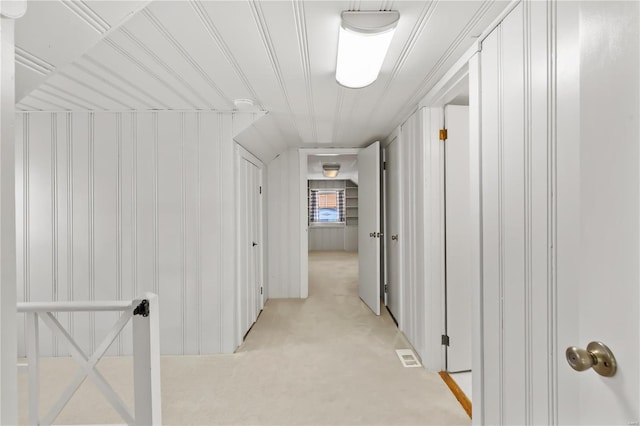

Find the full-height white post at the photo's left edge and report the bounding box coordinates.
[0,0,27,425]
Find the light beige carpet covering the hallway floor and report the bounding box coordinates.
[20,252,470,425]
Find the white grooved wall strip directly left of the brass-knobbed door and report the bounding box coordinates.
[479,2,556,424]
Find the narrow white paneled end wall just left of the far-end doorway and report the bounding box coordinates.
[267,149,307,298]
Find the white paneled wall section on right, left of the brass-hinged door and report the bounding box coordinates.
[398,108,444,371]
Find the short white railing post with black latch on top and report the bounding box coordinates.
[132,293,162,425]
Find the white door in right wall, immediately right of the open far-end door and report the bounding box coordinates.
[384,139,402,322]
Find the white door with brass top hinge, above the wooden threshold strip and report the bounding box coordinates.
[444,105,472,372]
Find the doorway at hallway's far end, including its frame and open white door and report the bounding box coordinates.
[300,146,383,315]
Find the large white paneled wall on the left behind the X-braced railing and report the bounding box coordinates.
[16,112,255,355]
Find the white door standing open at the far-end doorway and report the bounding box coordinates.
[358,142,382,315]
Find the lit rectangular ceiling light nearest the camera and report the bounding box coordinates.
[336,11,400,89]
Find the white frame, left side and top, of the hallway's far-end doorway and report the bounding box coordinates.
[298,148,360,299]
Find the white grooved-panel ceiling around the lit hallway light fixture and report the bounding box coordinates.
[16,0,508,161]
